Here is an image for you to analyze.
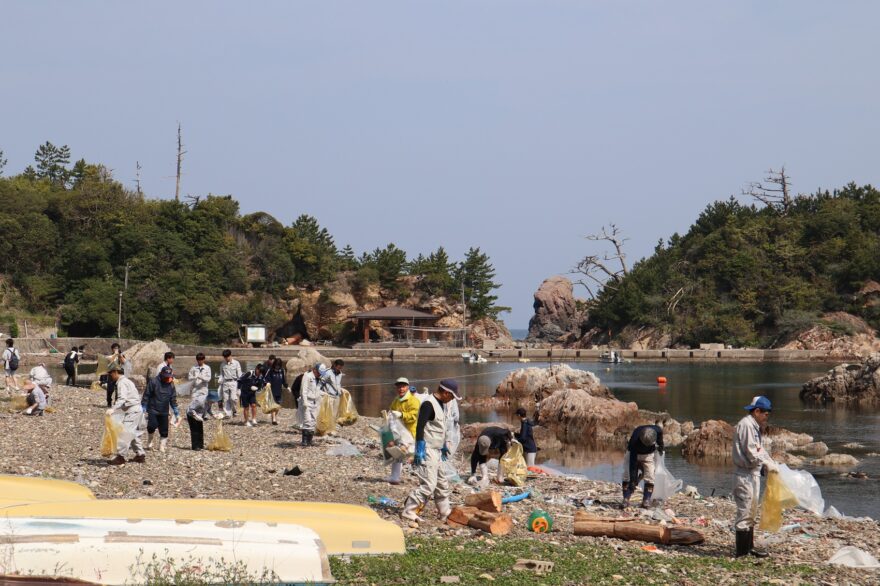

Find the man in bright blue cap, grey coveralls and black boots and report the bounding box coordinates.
[733,395,779,558]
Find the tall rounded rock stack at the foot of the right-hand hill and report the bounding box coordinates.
[526,276,583,344]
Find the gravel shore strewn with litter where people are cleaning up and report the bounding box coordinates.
[0,385,880,583]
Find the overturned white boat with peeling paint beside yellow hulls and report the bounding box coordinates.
[0,518,334,584]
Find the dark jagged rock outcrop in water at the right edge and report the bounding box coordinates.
[800,352,880,404]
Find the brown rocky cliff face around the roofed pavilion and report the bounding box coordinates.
[276,272,513,348]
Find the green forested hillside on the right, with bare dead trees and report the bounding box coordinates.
[584,184,880,346]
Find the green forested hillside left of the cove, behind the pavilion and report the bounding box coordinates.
[0,142,505,342]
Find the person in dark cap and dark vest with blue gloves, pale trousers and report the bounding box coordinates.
[400,379,461,522]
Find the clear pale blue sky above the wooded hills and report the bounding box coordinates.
[0,0,880,328]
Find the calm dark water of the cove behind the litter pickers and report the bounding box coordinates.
[49,362,880,519]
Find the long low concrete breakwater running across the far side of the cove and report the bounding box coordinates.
[16,338,860,363]
